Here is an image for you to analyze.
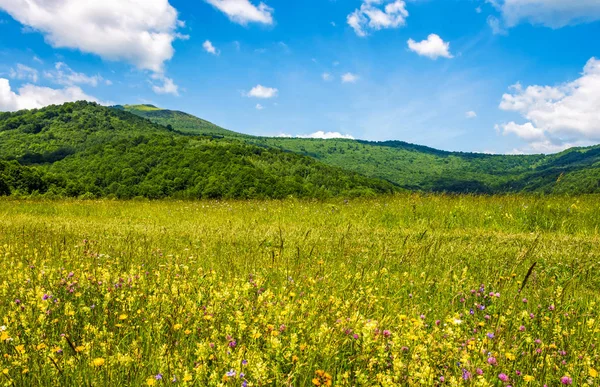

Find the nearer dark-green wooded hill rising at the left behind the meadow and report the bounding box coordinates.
[0,102,397,199]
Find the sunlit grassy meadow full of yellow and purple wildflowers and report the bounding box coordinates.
[0,195,600,386]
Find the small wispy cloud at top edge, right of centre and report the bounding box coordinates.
[346,0,408,36]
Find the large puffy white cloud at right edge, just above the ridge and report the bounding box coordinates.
[498,58,600,149]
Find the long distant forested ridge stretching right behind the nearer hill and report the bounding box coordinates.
[124,105,600,194]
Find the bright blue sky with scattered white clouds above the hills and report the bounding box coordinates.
[0,0,600,154]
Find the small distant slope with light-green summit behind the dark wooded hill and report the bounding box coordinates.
[115,105,242,136]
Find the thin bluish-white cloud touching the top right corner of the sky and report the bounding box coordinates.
[492,0,600,28]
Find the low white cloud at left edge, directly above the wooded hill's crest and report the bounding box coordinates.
[0,78,98,111]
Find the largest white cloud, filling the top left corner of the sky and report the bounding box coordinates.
[0,0,183,72]
